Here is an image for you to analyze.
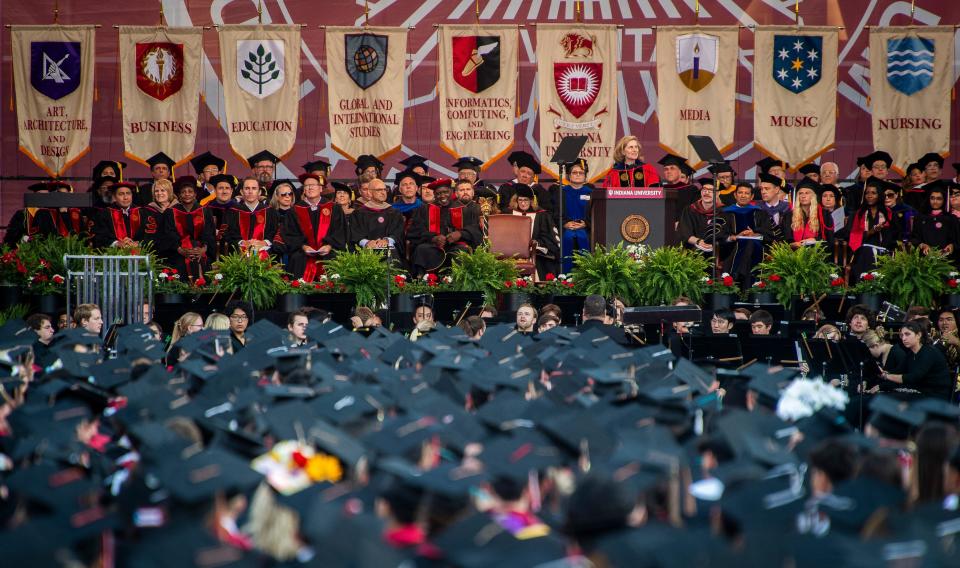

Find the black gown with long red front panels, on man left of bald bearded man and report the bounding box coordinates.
[283,201,348,282]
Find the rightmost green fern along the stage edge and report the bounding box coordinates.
[877,248,953,309]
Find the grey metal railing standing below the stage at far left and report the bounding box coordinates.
[63,255,153,331]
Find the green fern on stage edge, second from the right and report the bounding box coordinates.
[756,242,835,306]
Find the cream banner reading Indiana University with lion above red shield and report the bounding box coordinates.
[537,23,617,180]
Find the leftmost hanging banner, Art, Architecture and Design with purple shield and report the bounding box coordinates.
[11,26,94,176]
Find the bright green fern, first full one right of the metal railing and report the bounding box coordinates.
[210,252,286,310]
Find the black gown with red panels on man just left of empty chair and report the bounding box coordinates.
[407,202,483,276]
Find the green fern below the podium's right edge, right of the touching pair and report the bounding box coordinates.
[636,246,710,306]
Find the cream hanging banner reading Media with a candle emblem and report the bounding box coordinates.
[657,26,740,164]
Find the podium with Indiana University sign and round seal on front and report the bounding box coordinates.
[590,187,679,248]
